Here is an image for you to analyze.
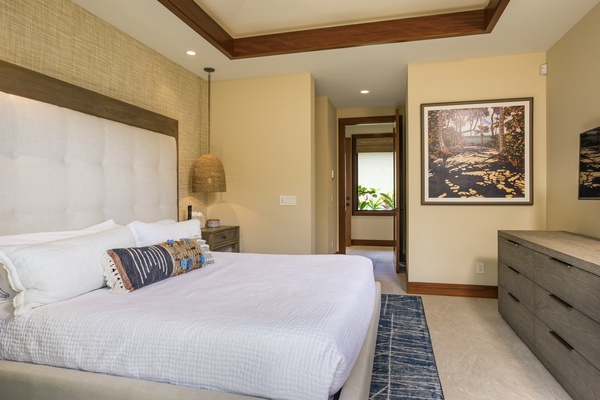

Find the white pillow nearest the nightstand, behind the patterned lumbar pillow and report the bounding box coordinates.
[127,219,201,247]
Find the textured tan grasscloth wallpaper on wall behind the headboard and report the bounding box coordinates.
[0,0,207,219]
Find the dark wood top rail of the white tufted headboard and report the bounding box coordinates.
[0,60,179,141]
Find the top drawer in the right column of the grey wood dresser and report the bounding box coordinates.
[535,256,600,322]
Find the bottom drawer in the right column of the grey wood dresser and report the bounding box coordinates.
[535,318,600,400]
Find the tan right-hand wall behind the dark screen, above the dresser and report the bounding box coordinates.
[548,5,600,238]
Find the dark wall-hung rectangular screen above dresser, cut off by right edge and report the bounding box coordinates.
[578,126,600,200]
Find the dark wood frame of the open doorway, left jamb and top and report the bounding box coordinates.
[338,115,404,254]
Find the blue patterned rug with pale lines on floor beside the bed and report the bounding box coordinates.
[369,294,444,400]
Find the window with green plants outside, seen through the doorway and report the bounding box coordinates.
[352,134,396,215]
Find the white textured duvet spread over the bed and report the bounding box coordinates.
[0,253,375,400]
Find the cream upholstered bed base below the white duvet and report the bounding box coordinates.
[0,282,381,400]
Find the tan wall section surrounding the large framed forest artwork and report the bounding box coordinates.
[407,54,546,285]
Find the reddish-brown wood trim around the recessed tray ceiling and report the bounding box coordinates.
[158,0,510,59]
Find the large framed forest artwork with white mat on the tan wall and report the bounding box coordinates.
[421,98,533,205]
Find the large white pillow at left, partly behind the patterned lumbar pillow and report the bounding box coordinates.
[0,226,135,316]
